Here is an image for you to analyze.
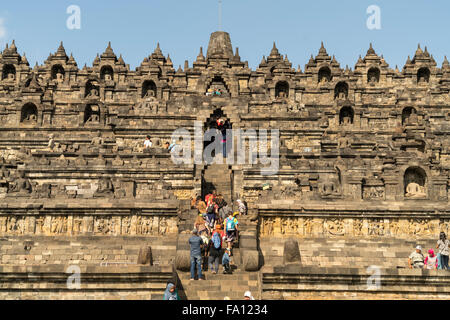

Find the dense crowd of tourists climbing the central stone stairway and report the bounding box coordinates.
[189,190,247,280]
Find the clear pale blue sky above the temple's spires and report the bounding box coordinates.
[0,0,450,70]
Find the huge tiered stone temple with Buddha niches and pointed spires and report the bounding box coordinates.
[0,32,450,300]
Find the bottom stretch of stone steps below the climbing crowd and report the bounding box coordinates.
[178,248,261,300]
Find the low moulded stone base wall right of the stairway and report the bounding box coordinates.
[262,267,450,300]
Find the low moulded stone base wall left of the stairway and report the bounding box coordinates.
[0,266,176,300]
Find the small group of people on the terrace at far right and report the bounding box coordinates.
[408,232,450,270]
